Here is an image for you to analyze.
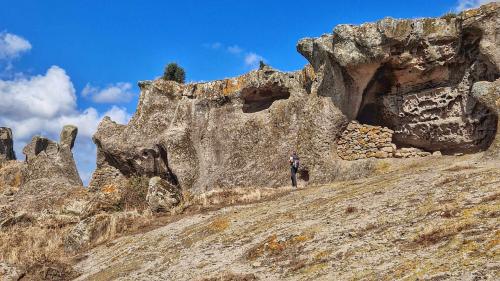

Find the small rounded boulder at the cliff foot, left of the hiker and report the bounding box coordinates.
[146,177,182,212]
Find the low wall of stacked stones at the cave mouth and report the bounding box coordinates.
[337,121,431,160]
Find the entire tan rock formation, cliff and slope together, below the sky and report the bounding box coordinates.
[0,4,500,280]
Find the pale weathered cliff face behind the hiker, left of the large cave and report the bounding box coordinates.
[90,67,346,191]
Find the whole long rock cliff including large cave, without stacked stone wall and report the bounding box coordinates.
[90,3,500,191]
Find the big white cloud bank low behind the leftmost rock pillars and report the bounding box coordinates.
[0,66,130,183]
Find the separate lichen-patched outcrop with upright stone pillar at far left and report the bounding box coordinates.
[0,126,83,211]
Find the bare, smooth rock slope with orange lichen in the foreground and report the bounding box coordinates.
[76,155,500,280]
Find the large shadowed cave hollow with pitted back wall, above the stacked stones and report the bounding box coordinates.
[356,59,498,154]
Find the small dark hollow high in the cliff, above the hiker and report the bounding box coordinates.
[241,86,290,113]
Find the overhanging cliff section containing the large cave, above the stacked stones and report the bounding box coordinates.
[297,3,500,153]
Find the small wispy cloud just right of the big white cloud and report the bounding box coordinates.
[82,82,134,103]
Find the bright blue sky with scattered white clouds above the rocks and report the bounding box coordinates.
[0,0,487,184]
